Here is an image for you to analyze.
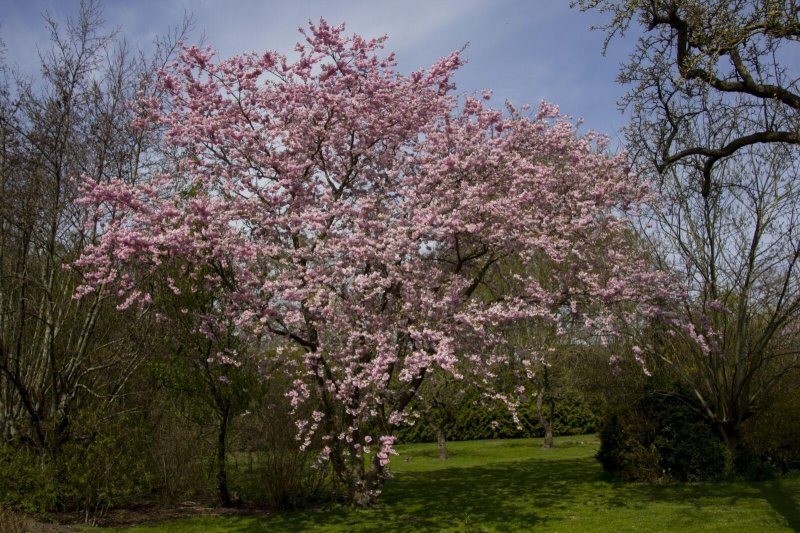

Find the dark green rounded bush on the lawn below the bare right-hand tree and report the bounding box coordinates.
[597,390,731,481]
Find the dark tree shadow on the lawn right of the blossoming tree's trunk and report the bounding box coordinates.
[231,458,602,533]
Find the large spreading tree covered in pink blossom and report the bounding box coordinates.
[78,21,671,500]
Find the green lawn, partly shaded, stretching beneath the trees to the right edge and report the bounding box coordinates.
[81,437,800,533]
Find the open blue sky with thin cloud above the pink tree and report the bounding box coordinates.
[0,0,634,146]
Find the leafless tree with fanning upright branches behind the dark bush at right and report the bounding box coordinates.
[647,142,800,448]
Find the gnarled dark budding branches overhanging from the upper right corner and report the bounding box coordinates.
[573,0,800,187]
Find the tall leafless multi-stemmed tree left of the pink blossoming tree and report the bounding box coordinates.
[0,1,188,452]
